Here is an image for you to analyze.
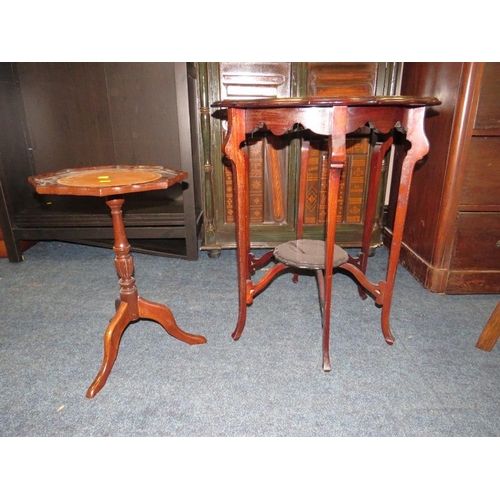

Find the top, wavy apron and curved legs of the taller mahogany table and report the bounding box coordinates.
[213,96,440,371]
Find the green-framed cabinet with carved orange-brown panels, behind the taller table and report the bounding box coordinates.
[198,62,400,256]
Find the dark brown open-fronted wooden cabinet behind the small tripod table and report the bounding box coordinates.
[0,63,202,262]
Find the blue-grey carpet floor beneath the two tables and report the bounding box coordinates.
[0,242,500,437]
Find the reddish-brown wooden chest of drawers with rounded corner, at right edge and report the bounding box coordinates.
[387,62,500,294]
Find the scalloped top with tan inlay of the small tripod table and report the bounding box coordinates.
[29,165,188,196]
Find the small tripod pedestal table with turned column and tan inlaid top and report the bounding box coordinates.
[28,165,206,398]
